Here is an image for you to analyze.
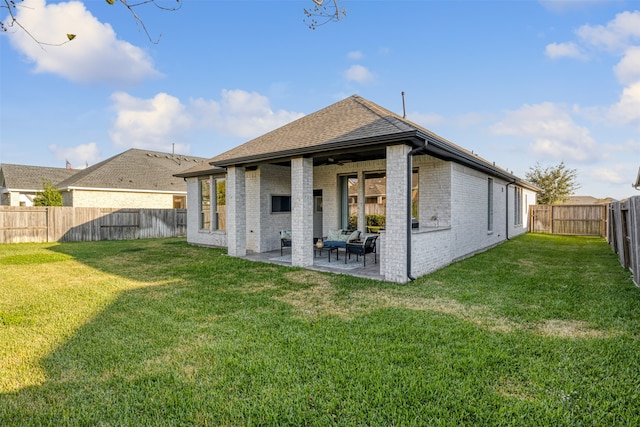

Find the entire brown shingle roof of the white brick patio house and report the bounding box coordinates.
[210,95,538,190]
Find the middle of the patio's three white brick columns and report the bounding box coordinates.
[291,157,313,267]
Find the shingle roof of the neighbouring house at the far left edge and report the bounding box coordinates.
[0,163,78,191]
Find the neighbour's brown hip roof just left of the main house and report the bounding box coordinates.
[58,148,210,192]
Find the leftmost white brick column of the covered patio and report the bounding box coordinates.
[226,166,247,257]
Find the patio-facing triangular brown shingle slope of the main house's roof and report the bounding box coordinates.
[210,95,417,166]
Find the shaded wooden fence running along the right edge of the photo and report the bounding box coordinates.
[607,196,640,286]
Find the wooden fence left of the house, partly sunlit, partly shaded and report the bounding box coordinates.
[0,206,187,243]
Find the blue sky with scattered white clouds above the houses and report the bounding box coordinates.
[0,0,640,199]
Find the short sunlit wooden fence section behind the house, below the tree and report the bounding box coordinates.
[529,205,607,237]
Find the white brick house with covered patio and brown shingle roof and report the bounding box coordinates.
[178,95,537,283]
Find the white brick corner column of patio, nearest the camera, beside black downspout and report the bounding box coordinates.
[380,144,411,283]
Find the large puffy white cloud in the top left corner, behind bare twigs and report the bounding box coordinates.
[8,0,160,84]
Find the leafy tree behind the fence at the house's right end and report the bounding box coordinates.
[526,162,580,205]
